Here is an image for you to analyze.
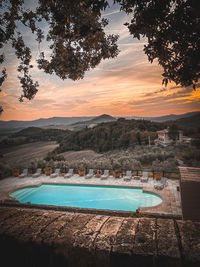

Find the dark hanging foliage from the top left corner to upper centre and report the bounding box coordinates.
[0,0,119,101]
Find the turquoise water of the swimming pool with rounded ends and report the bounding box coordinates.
[10,184,162,211]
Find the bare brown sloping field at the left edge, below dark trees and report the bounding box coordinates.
[0,142,58,167]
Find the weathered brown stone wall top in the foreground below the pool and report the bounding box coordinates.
[0,207,200,267]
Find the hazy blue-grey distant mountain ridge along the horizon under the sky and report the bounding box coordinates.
[0,111,200,135]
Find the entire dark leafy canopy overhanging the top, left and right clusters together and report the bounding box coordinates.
[0,0,200,104]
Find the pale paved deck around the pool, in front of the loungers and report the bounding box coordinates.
[0,174,182,217]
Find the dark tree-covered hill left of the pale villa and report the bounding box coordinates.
[57,118,165,153]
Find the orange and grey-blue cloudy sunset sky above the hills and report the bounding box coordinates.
[0,1,200,120]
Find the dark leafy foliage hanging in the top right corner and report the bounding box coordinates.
[116,0,200,89]
